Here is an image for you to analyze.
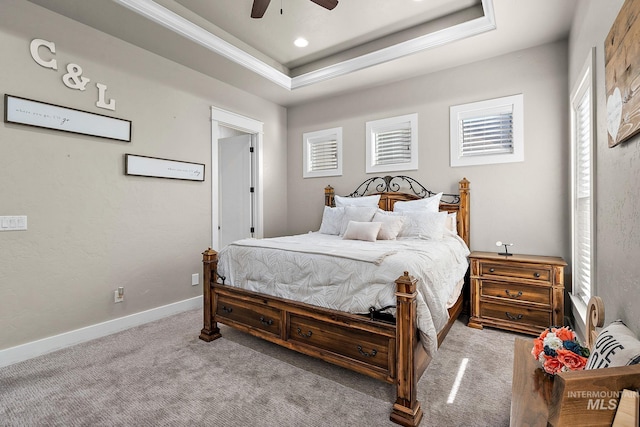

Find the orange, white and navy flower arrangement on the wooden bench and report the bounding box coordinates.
[531,326,589,375]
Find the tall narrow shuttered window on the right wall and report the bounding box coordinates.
[571,52,595,313]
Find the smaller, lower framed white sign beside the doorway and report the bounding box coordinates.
[124,154,204,181]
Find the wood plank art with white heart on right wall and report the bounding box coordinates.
[604,0,640,147]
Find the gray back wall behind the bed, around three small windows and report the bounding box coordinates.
[288,42,570,257]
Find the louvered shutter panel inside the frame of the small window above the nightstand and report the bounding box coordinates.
[460,111,513,157]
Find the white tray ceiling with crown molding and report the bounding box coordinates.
[30,0,576,106]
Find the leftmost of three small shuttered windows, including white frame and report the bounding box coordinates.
[302,127,342,178]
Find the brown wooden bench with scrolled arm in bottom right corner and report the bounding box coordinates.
[511,297,640,427]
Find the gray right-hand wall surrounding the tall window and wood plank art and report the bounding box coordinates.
[569,0,640,334]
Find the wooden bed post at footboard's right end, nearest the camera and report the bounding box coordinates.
[390,271,422,427]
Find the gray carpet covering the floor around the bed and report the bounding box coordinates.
[0,310,517,427]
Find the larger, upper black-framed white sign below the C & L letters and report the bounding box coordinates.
[4,94,131,142]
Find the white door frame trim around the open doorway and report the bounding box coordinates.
[211,106,264,251]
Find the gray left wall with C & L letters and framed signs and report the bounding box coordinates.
[0,0,287,349]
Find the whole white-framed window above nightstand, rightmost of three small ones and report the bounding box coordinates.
[449,94,524,167]
